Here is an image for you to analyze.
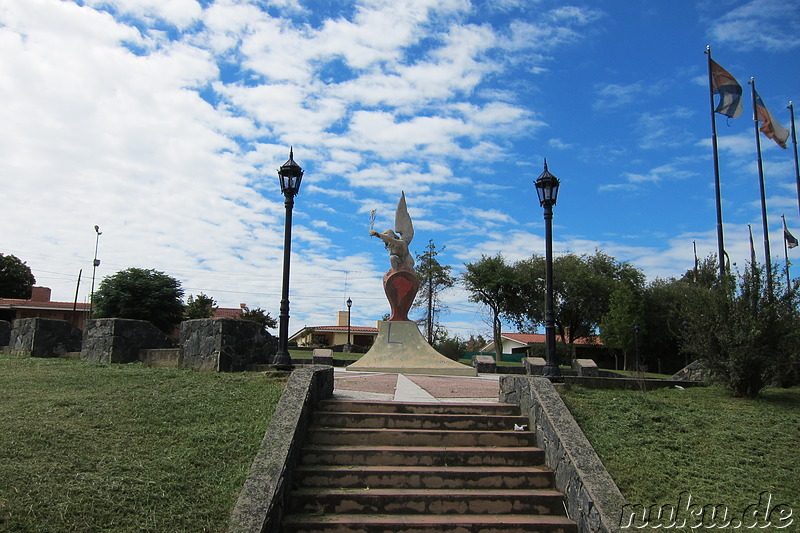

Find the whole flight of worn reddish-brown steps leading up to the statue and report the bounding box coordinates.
[282,400,577,533]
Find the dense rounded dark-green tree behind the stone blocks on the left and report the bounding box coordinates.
[94,268,183,334]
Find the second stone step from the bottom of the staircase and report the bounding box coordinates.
[289,488,564,515]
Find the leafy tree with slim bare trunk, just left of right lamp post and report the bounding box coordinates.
[461,254,520,361]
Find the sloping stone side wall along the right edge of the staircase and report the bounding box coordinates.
[500,376,625,533]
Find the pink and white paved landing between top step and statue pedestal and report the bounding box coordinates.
[333,368,500,403]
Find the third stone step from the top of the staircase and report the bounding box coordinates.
[309,427,536,447]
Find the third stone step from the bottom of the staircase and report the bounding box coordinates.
[295,465,553,490]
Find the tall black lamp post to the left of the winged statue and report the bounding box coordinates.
[272,148,303,370]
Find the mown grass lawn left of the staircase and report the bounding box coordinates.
[0,354,284,532]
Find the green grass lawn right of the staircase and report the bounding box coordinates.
[561,387,800,520]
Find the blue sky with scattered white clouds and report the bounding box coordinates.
[0,0,800,337]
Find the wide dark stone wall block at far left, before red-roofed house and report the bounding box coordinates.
[8,318,81,357]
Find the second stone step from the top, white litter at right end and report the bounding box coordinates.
[312,411,528,431]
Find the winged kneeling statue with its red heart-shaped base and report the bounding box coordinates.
[369,193,419,321]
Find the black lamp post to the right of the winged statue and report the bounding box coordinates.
[536,159,561,377]
